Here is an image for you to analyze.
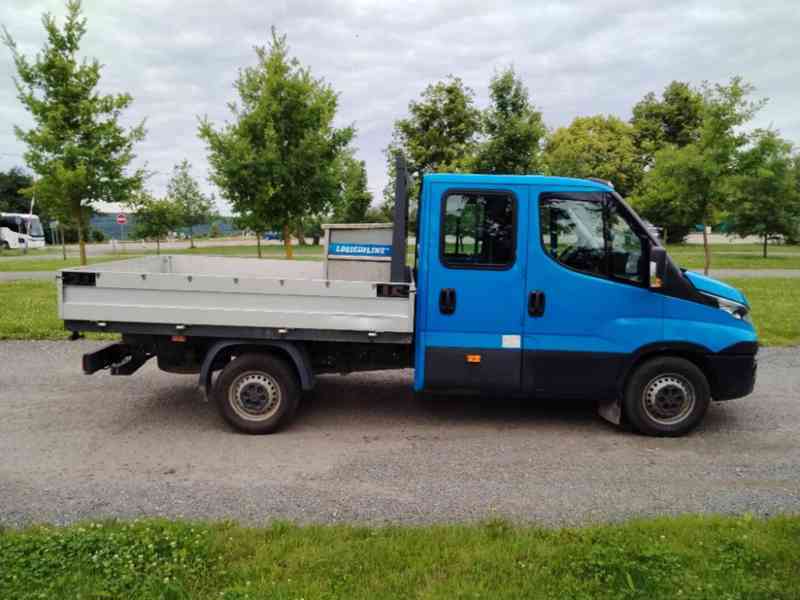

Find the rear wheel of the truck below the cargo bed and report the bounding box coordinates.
[214,354,301,434]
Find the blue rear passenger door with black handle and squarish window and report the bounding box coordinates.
[418,182,527,392]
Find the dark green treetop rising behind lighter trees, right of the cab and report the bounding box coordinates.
[631,81,703,168]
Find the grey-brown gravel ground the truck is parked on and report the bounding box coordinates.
[0,341,800,525]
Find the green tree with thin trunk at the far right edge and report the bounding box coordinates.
[728,130,800,258]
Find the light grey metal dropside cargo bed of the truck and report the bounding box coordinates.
[57,255,415,343]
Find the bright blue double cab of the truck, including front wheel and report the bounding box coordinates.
[414,174,758,435]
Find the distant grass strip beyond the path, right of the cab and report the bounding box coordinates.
[667,244,800,269]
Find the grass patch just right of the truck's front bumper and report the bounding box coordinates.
[725,277,800,346]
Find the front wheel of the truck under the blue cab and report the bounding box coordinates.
[623,356,711,437]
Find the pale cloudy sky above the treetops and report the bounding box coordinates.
[0,0,800,213]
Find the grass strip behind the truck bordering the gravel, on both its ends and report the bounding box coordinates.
[0,278,800,346]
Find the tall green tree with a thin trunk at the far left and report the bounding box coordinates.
[2,0,145,265]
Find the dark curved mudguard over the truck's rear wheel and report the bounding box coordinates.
[198,340,314,398]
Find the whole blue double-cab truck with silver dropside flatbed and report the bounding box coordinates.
[59,158,758,436]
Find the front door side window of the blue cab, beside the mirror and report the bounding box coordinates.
[539,194,643,283]
